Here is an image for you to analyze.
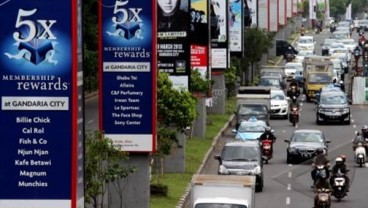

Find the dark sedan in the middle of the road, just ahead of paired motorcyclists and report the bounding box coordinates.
[284,129,330,164]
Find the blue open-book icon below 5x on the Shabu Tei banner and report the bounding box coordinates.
[106,23,143,40]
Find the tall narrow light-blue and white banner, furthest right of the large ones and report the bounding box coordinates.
[229,0,243,57]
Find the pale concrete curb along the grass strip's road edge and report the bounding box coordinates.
[175,115,235,208]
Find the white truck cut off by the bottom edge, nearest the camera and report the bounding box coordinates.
[190,174,255,208]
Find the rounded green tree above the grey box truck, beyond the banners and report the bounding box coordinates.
[242,27,275,83]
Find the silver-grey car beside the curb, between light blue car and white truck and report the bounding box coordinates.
[214,141,267,192]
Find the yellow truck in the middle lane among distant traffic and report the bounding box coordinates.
[303,56,334,102]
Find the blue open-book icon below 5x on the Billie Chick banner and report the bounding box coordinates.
[5,42,57,65]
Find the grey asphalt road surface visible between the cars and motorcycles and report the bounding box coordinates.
[202,31,368,208]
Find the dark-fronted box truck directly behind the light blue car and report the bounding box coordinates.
[234,86,271,129]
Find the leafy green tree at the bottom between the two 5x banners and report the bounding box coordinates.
[84,131,135,208]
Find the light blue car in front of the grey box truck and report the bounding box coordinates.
[232,116,274,141]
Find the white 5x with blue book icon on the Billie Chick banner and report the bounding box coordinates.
[5,9,57,65]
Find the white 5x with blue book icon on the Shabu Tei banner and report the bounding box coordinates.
[106,0,143,40]
